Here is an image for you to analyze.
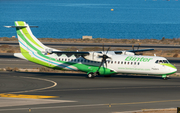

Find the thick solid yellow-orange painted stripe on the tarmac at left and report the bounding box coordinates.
[0,94,58,99]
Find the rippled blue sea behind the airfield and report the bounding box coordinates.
[0,0,180,39]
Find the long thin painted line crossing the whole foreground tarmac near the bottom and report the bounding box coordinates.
[0,100,180,111]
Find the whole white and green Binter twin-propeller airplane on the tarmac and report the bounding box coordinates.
[4,21,177,80]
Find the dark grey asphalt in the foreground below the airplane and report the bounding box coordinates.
[0,72,180,113]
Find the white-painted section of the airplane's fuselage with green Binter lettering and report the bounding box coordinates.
[48,54,177,75]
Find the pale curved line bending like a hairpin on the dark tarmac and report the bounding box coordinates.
[4,77,57,93]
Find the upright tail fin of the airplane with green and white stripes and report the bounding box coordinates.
[15,21,53,53]
